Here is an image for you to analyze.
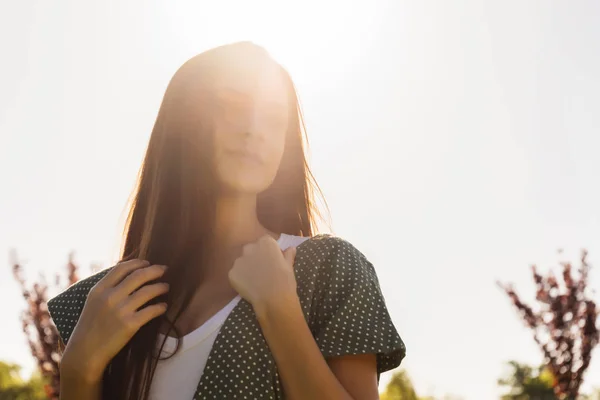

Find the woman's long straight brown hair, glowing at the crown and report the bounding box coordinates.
[103,42,322,400]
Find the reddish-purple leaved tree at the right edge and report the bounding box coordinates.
[498,250,600,400]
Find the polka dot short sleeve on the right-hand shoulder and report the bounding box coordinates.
[315,239,406,378]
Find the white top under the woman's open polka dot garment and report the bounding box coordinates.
[150,234,308,400]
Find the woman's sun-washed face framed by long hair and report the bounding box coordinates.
[213,63,289,194]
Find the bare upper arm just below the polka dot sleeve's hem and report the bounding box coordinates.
[327,354,379,400]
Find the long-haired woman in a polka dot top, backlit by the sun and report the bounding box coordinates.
[48,42,405,400]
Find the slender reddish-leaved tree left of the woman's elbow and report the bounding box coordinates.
[11,252,79,400]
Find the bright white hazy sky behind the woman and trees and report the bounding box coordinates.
[0,0,600,400]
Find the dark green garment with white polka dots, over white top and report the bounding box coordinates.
[48,235,406,400]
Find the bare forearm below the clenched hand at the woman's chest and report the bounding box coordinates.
[254,295,352,400]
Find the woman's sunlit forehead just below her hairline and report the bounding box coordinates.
[213,62,288,107]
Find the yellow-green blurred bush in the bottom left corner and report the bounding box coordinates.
[0,361,47,400]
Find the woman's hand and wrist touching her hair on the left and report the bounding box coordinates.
[61,260,169,383]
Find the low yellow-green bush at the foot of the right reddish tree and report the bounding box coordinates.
[498,361,557,400]
